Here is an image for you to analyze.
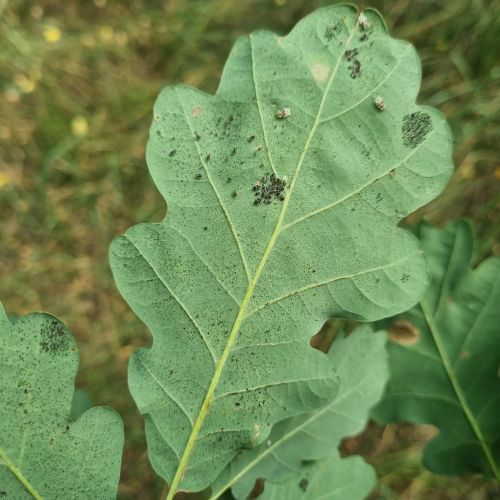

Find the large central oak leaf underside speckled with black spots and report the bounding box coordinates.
[110,6,452,495]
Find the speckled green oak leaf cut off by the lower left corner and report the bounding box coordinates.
[0,305,123,500]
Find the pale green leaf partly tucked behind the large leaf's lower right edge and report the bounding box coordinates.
[211,326,388,500]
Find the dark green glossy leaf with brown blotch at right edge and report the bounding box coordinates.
[374,221,500,479]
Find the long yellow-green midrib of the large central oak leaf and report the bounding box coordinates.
[166,13,359,500]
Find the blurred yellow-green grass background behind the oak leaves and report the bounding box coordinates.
[0,0,500,499]
